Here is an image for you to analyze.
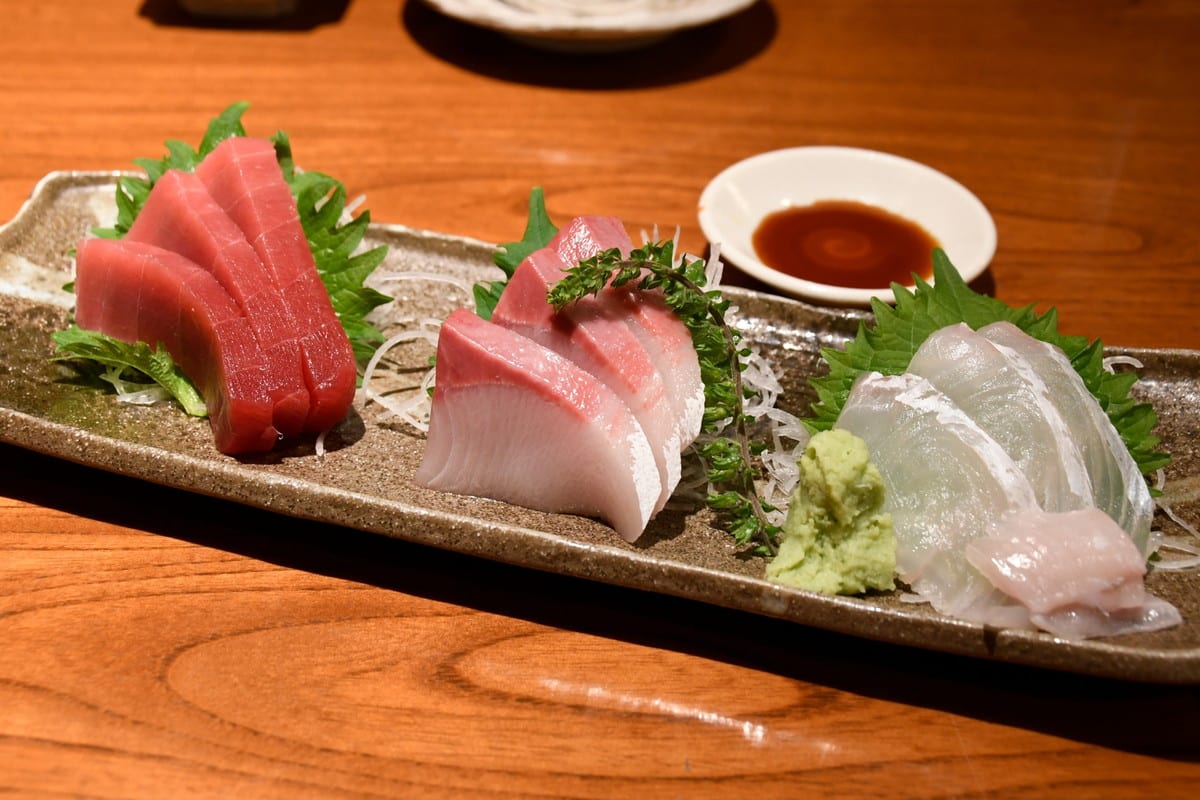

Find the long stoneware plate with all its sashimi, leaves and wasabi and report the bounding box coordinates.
[0,103,1200,684]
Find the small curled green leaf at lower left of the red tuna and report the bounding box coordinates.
[50,325,208,416]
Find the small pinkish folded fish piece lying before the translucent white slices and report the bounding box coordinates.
[965,509,1182,639]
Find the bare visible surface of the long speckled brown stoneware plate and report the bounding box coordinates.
[7,173,1200,684]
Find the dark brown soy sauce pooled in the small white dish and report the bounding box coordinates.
[751,200,940,289]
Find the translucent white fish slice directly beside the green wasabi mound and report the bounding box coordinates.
[838,373,1037,624]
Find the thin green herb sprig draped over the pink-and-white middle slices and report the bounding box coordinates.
[547,241,780,555]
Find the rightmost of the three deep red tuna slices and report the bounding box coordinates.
[196,137,358,431]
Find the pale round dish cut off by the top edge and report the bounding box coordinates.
[425,0,756,52]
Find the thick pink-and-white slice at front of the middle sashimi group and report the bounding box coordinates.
[416,309,660,541]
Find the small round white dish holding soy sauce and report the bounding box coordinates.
[700,146,996,306]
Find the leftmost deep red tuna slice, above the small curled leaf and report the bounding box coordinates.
[76,239,278,453]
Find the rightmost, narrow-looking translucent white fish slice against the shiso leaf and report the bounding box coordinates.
[979,323,1154,558]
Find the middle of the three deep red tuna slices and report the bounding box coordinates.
[126,169,308,437]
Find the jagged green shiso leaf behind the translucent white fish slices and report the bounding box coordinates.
[804,249,1170,474]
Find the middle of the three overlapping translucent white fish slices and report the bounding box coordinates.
[908,324,1093,511]
